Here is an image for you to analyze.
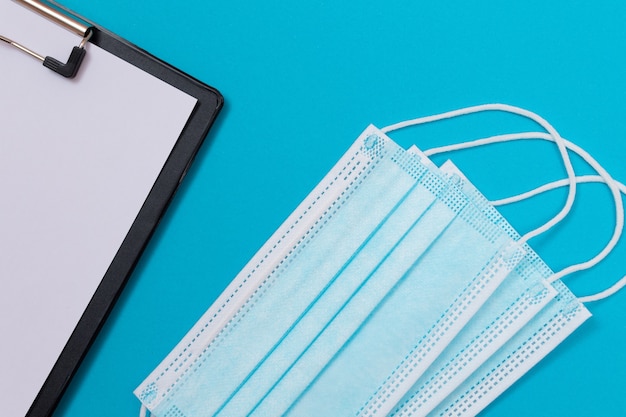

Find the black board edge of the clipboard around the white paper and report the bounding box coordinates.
[4,0,223,417]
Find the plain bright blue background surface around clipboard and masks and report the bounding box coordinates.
[54,0,626,417]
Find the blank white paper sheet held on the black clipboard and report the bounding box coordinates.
[0,0,196,416]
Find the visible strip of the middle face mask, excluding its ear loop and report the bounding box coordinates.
[386,162,580,416]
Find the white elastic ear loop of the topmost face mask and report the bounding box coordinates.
[381,103,576,243]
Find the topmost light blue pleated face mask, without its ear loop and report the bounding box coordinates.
[136,124,523,417]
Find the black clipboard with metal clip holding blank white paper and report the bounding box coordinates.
[0,0,223,417]
